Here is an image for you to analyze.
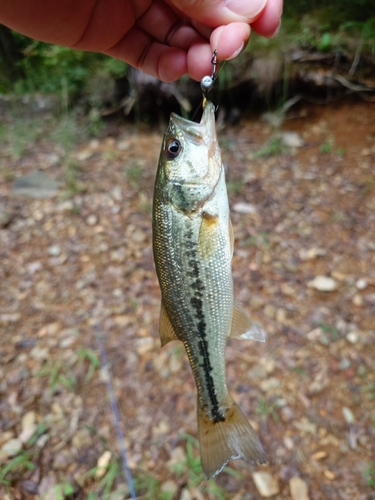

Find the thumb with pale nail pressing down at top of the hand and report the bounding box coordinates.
[169,0,267,28]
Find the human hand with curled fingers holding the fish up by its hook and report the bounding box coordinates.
[0,0,282,81]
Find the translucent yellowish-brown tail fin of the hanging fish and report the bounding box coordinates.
[198,400,266,479]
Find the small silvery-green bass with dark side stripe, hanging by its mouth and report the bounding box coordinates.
[153,101,266,479]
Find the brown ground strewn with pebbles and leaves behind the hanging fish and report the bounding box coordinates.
[0,94,375,500]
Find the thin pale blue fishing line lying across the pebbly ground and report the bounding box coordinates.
[94,324,137,500]
